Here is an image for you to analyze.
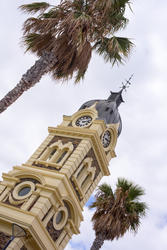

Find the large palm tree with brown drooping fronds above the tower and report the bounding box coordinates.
[0,0,133,113]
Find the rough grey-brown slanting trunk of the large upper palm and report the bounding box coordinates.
[0,51,57,113]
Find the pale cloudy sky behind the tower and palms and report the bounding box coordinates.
[0,0,167,250]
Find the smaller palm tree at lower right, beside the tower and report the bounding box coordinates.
[90,178,147,250]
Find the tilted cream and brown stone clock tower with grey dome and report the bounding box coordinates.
[0,90,123,250]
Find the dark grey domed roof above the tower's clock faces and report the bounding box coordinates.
[79,89,124,135]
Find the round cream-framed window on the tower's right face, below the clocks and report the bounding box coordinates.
[53,207,68,230]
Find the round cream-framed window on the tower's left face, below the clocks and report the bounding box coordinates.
[13,181,35,200]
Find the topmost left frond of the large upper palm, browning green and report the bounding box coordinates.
[19,2,50,14]
